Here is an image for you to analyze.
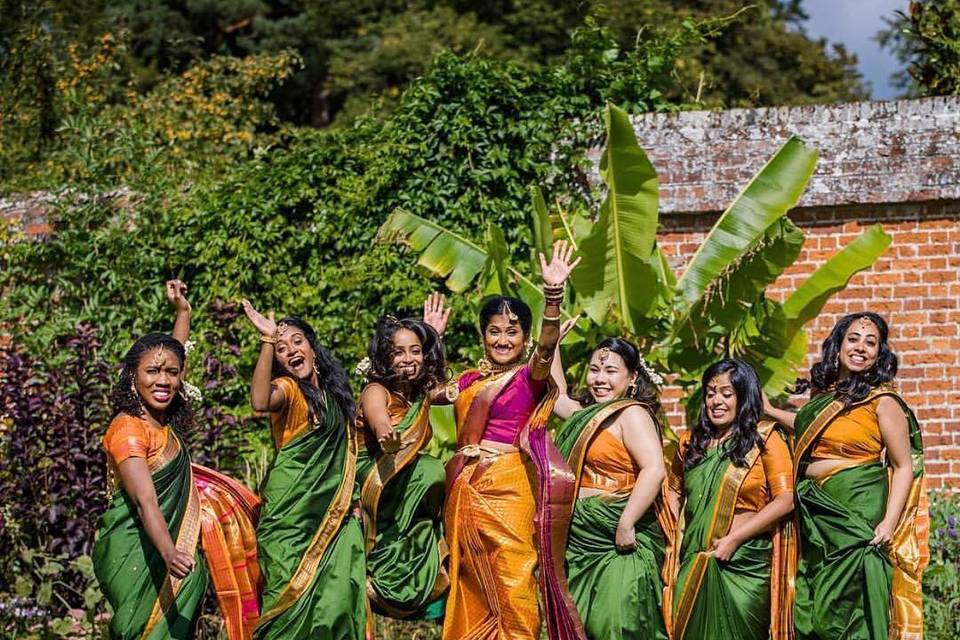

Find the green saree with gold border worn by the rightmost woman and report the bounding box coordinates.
[795,388,929,640]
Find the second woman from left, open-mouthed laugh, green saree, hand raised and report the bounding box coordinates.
[243,300,366,640]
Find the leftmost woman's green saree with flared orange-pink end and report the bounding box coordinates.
[93,436,260,640]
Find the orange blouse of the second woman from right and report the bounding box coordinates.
[670,430,794,512]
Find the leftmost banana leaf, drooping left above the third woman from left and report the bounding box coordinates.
[377,209,487,293]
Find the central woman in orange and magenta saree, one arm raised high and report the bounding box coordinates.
[443,242,583,640]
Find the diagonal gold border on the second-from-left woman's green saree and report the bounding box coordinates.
[258,420,357,628]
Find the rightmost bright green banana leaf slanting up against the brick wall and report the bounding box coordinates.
[783,224,892,331]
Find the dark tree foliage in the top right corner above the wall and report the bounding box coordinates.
[877,0,960,97]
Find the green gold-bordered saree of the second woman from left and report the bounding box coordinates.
[254,394,366,640]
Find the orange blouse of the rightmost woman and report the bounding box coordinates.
[810,396,883,462]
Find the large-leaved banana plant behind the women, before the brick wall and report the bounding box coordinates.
[380,105,890,422]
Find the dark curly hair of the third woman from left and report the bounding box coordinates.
[367,316,448,400]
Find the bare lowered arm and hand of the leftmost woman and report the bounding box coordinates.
[118,458,194,578]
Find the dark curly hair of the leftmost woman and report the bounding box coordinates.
[110,333,193,436]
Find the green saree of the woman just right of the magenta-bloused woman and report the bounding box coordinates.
[557,399,672,640]
